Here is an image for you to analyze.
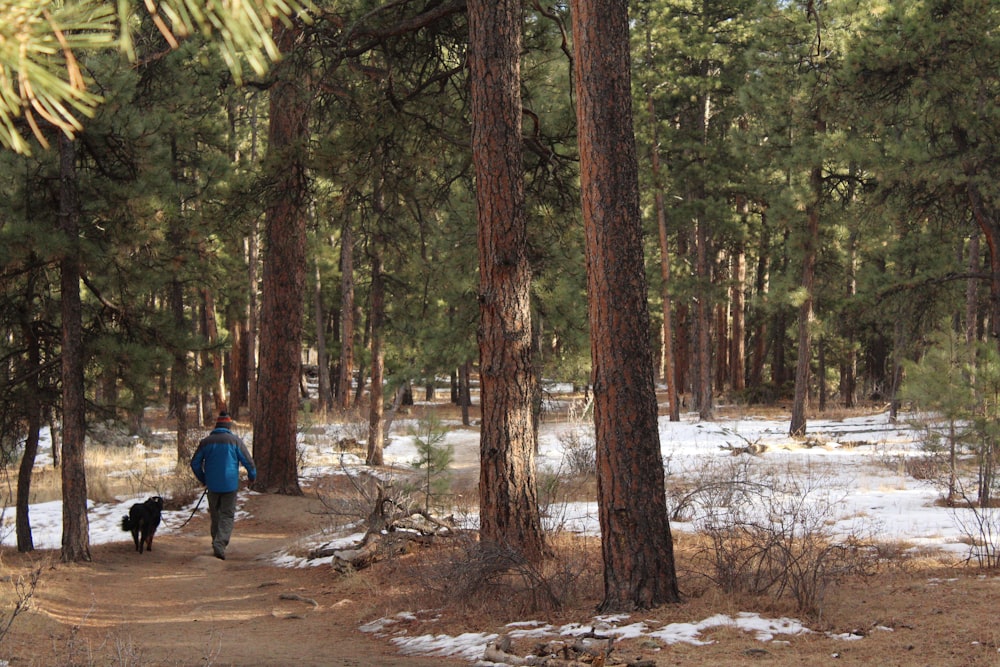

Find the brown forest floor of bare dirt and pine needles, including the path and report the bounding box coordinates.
[0,404,1000,667]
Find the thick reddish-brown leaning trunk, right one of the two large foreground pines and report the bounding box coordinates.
[571,0,680,612]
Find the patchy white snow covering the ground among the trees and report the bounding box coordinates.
[2,414,993,660]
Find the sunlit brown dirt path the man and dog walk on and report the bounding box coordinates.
[0,495,465,667]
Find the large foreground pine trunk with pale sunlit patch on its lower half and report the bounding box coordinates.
[468,0,546,561]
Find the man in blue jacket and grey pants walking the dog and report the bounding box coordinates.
[191,411,257,560]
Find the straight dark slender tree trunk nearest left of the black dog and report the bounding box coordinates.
[59,133,90,563]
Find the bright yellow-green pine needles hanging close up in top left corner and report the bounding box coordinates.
[0,0,312,154]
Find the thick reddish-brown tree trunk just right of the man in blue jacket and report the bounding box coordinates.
[253,21,309,495]
